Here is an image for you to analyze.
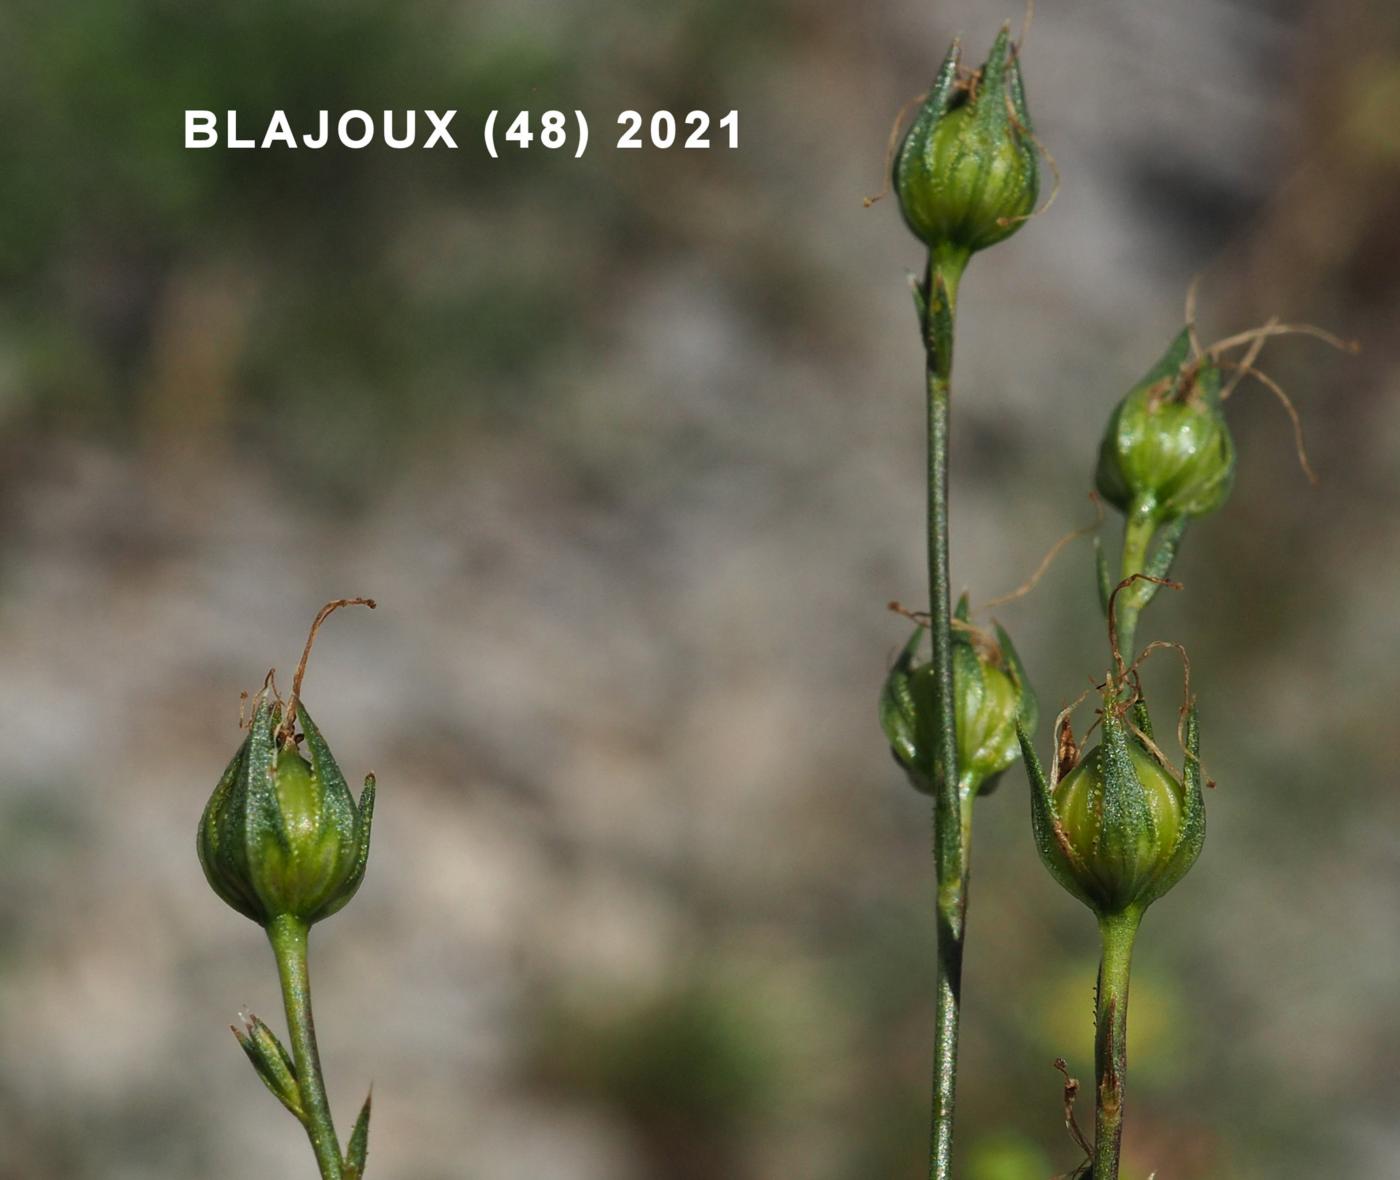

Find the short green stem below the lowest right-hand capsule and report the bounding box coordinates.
[1092,910,1142,1180]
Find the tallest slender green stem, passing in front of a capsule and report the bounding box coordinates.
[923,239,970,1180]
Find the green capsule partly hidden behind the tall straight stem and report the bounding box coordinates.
[879,599,1037,794]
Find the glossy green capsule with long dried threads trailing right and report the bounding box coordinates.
[1095,329,1235,525]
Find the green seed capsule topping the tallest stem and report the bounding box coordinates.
[893,28,1040,260]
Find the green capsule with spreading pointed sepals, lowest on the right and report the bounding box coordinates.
[1022,700,1205,917]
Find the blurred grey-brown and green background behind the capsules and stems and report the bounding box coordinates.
[0,0,1400,1180]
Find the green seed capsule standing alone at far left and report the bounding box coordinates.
[196,698,374,925]
